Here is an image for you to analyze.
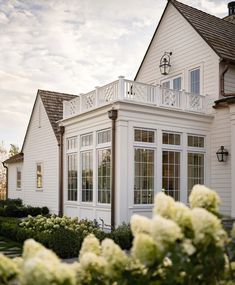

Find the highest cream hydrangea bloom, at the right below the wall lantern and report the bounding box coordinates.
[189,185,220,213]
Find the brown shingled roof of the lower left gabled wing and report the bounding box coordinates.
[21,89,77,152]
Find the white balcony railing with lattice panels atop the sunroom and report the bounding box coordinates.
[63,76,206,119]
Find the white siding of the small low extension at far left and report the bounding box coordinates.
[8,162,24,200]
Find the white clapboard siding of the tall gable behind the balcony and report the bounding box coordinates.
[136,4,219,104]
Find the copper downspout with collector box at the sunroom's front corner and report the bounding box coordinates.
[108,107,118,231]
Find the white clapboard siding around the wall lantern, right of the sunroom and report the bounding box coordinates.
[211,108,231,215]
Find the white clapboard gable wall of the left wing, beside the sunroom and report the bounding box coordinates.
[22,97,58,213]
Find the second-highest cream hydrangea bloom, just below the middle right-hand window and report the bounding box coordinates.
[153,192,175,218]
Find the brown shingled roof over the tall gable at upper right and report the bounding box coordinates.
[135,0,235,80]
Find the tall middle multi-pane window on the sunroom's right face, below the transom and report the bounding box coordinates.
[162,150,180,201]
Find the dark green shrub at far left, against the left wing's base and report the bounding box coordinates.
[0,199,49,218]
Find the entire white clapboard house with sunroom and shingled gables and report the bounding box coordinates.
[5,0,235,226]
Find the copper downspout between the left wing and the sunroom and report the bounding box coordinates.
[58,126,64,217]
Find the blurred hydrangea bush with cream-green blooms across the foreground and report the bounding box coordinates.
[0,186,235,285]
